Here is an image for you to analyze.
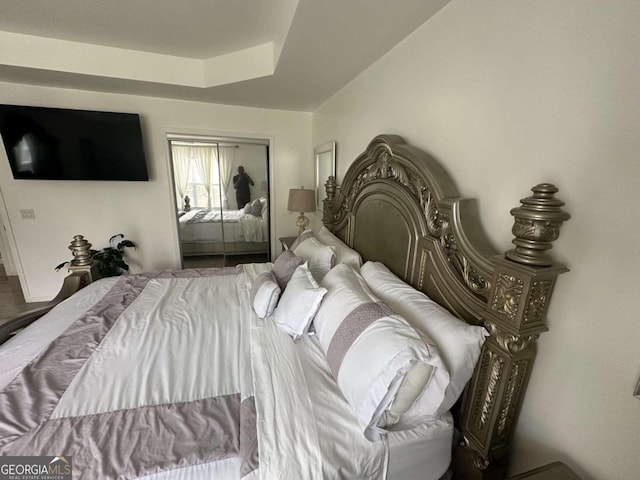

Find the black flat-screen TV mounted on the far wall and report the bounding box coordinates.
[0,105,149,181]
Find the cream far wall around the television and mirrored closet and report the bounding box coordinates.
[0,83,313,301]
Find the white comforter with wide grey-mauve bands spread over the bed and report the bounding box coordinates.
[0,266,387,479]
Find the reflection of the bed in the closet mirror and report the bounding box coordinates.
[179,197,269,256]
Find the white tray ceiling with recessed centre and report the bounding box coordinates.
[0,0,448,111]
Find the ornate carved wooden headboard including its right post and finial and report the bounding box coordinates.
[323,135,569,479]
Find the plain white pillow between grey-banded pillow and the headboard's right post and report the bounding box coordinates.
[360,262,489,415]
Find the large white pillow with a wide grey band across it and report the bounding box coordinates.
[313,264,449,440]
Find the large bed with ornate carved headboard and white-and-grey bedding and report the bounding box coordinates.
[0,135,568,479]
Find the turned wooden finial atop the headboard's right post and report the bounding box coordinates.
[506,183,571,267]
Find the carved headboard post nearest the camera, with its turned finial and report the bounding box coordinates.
[454,183,570,480]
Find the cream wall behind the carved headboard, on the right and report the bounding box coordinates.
[313,0,640,480]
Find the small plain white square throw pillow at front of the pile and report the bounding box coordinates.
[274,263,327,340]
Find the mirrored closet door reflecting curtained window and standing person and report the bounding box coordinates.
[169,136,270,268]
